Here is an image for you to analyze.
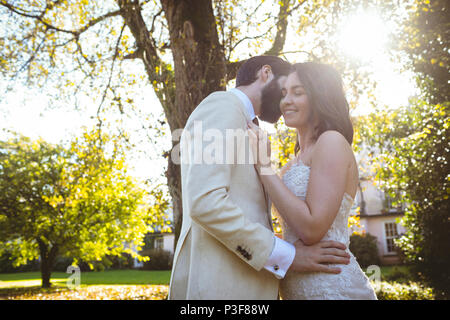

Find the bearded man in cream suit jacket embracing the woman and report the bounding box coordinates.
[169,56,349,300]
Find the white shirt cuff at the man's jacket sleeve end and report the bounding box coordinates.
[264,236,295,279]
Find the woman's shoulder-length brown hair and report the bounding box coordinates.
[291,62,353,154]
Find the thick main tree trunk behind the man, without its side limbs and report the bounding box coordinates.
[161,0,226,248]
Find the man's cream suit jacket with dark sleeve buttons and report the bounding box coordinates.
[169,92,278,300]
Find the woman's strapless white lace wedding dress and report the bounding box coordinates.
[280,161,376,300]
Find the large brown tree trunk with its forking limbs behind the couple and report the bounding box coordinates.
[117,0,291,249]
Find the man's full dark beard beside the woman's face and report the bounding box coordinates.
[259,78,281,123]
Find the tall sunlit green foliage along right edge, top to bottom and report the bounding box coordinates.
[356,0,450,298]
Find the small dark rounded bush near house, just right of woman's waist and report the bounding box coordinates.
[349,233,380,268]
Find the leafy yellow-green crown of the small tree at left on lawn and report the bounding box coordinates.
[0,131,165,286]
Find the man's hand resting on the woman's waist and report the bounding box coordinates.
[290,240,350,274]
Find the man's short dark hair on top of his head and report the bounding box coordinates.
[236,56,291,87]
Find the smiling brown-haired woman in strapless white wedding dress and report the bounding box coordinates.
[248,62,376,300]
